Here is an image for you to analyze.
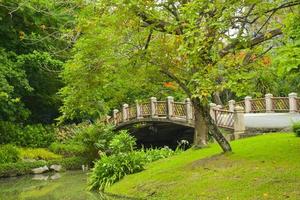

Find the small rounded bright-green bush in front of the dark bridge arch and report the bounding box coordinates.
[109,130,136,154]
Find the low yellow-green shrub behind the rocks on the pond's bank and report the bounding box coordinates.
[20,148,62,160]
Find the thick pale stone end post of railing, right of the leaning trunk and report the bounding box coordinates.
[233,106,246,139]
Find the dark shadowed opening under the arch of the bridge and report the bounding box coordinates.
[117,122,194,149]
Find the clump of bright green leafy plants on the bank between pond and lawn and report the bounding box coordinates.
[89,131,180,191]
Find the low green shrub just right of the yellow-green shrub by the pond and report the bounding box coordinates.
[49,142,86,157]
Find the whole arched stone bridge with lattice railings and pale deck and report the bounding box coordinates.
[107,93,300,144]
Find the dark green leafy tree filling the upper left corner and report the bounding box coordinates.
[0,0,79,123]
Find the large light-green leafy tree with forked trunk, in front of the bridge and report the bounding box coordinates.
[62,0,300,151]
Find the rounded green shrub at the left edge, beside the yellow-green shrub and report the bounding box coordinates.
[0,144,20,164]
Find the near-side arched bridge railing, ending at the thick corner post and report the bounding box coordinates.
[108,97,243,132]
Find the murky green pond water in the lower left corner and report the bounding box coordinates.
[0,171,123,200]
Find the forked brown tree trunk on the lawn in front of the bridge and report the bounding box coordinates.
[192,98,231,152]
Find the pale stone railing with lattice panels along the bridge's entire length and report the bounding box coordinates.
[108,93,300,134]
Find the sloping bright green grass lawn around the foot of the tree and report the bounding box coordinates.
[106,133,300,200]
